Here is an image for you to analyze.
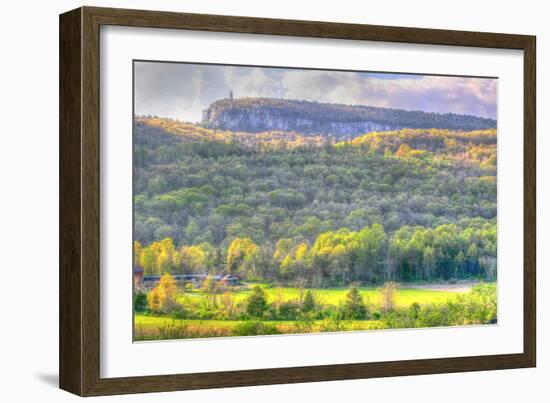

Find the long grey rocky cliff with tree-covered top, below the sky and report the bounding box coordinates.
[201,98,496,137]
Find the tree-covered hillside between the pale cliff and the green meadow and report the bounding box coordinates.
[134,116,497,286]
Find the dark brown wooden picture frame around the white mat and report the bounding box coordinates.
[59,7,536,396]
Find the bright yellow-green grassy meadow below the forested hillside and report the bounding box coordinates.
[134,283,496,341]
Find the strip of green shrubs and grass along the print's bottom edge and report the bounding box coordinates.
[134,284,497,340]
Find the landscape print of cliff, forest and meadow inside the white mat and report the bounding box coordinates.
[134,60,498,341]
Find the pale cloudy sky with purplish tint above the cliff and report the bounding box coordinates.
[134,62,497,122]
